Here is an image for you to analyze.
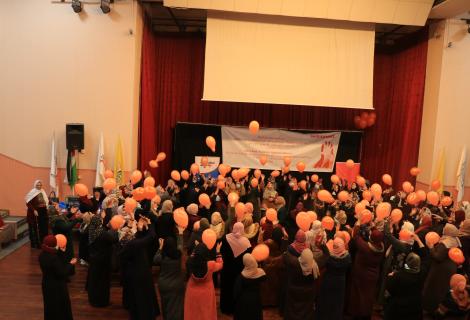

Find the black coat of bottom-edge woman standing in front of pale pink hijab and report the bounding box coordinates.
[233,274,266,320]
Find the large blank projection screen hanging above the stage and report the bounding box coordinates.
[203,11,375,109]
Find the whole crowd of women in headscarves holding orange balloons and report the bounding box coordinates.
[26,165,470,320]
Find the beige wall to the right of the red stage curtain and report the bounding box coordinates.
[419,20,470,186]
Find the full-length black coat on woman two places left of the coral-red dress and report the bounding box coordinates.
[119,225,160,320]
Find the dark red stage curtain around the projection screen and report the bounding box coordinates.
[139,20,427,190]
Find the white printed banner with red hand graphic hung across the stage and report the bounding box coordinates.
[222,126,341,172]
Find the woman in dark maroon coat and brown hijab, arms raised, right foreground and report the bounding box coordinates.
[348,227,384,319]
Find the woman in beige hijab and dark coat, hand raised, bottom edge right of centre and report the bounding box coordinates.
[284,248,320,320]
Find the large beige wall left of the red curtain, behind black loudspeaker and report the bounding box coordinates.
[0,0,142,214]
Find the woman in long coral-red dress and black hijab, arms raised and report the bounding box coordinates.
[184,243,223,320]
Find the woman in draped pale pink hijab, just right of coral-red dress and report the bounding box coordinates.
[220,222,251,314]
